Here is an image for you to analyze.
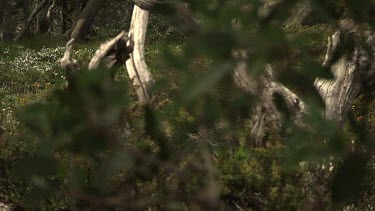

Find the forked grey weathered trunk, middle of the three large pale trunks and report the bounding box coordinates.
[233,51,307,146]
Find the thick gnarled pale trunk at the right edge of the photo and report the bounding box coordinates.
[315,27,374,125]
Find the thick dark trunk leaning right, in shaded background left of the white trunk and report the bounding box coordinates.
[71,0,103,40]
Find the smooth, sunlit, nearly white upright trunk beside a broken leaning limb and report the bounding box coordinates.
[126,5,153,103]
